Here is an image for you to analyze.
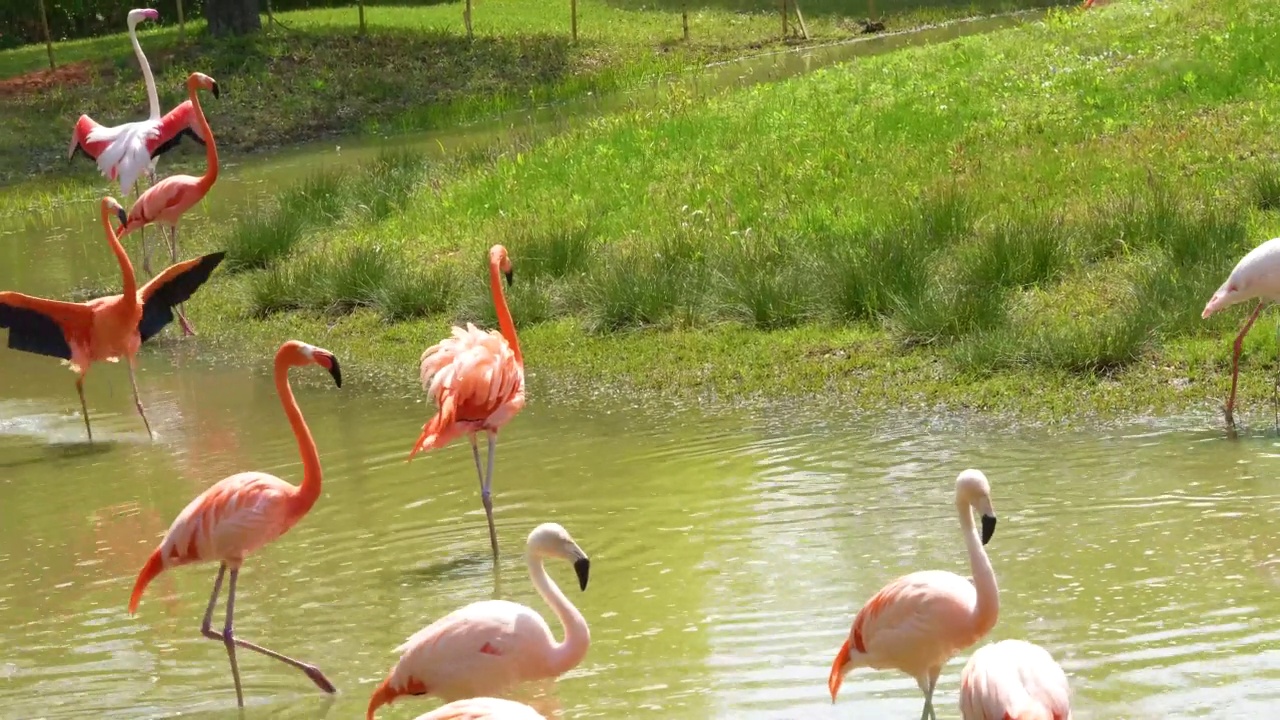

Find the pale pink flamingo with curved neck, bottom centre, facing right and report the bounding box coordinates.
[366,523,591,720]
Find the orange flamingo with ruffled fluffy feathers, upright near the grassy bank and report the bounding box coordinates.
[408,245,525,560]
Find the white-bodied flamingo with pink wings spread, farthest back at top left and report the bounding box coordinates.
[67,8,205,275]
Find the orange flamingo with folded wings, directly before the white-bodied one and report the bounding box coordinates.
[119,73,219,336]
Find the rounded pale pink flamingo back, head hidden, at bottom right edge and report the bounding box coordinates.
[960,641,1071,720]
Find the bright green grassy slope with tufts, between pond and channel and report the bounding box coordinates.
[167,0,1280,416]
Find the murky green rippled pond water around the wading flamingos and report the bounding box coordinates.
[0,9,1280,720]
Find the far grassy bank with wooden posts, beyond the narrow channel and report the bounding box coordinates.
[0,0,1051,182]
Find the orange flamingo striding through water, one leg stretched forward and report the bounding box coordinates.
[129,340,342,707]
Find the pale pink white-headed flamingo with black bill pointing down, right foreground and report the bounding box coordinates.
[827,470,1000,720]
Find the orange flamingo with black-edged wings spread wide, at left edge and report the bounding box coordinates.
[0,197,225,442]
